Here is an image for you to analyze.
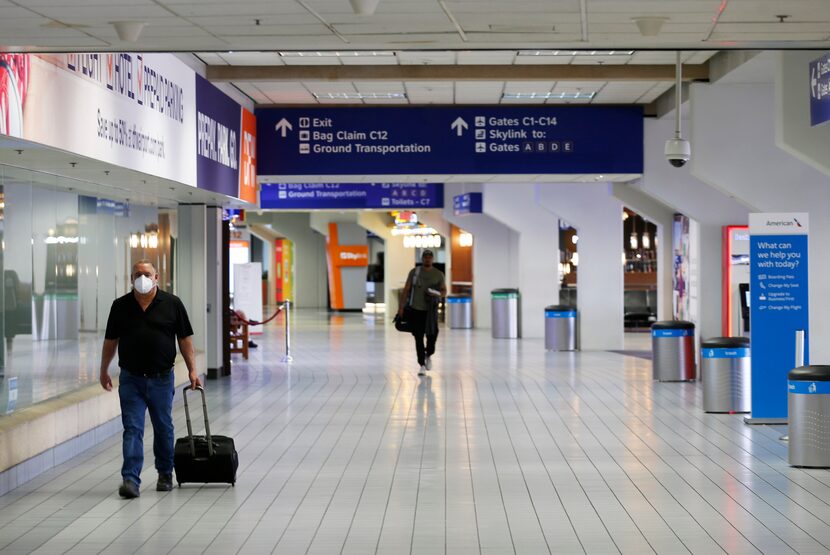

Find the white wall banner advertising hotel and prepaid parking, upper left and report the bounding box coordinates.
[0,53,196,186]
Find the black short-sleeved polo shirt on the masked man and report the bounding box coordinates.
[105,288,193,372]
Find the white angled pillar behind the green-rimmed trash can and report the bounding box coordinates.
[444,183,519,329]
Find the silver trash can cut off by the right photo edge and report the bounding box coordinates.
[787,366,830,468]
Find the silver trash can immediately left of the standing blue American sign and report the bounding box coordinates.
[700,337,752,413]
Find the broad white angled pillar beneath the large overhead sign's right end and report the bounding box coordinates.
[540,183,623,350]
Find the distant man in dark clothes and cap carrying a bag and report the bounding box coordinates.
[398,249,447,376]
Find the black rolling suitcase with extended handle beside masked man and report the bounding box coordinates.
[173,386,239,487]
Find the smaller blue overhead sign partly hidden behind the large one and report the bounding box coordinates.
[260,183,444,210]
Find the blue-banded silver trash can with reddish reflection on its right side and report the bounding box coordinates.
[651,320,696,382]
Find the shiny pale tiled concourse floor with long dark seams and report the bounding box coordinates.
[0,313,830,554]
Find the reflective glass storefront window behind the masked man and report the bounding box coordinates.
[0,165,175,416]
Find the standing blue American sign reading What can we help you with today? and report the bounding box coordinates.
[749,214,810,422]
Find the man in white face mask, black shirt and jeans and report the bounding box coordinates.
[101,260,201,499]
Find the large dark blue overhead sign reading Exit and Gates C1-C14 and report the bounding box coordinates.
[256,106,643,176]
